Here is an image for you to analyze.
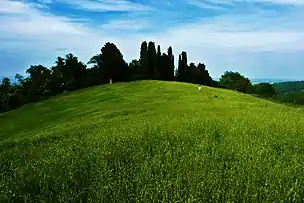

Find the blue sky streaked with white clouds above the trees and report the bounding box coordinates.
[0,0,304,80]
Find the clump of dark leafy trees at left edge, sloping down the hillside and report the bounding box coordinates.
[0,54,91,112]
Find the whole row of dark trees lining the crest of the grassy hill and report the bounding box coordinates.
[0,41,274,112]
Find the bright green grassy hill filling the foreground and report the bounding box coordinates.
[0,81,304,202]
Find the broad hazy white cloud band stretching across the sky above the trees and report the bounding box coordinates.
[0,0,304,79]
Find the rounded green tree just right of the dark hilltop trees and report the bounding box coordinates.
[219,71,253,93]
